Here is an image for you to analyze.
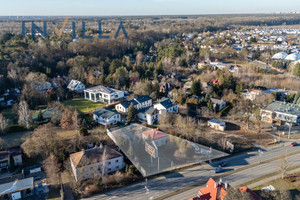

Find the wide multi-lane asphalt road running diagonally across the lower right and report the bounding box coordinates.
[85,143,300,200]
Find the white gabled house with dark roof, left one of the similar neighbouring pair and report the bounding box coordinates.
[115,95,152,113]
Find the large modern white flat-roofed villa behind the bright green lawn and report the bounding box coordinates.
[84,85,124,104]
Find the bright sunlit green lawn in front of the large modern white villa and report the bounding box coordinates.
[64,98,104,113]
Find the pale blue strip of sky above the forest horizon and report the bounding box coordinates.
[0,0,300,16]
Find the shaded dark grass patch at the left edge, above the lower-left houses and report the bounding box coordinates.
[0,131,32,148]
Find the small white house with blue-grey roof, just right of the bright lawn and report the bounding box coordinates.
[93,108,121,126]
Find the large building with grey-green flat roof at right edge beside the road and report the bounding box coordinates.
[261,101,300,126]
